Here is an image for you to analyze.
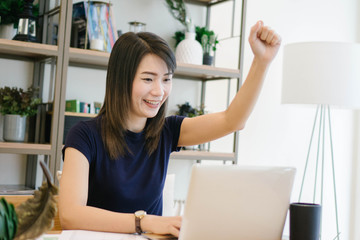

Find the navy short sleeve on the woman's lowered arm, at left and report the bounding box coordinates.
[62,121,95,162]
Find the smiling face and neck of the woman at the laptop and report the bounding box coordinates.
[127,54,172,132]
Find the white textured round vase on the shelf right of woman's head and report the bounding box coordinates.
[175,32,203,65]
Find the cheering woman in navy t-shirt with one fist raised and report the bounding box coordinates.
[59,21,281,236]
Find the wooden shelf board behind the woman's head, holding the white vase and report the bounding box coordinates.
[69,48,240,80]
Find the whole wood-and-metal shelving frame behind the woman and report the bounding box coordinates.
[0,0,246,189]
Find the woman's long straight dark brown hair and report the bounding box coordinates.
[98,32,176,159]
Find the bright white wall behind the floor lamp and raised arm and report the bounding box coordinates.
[239,0,359,239]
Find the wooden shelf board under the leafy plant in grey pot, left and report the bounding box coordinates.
[0,142,51,155]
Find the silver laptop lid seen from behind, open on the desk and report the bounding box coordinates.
[179,165,295,240]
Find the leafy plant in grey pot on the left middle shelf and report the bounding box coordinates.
[0,87,41,142]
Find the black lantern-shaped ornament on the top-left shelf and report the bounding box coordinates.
[13,0,37,42]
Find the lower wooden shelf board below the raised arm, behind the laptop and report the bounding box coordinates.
[170,150,235,161]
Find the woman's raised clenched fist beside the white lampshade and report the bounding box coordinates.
[249,21,281,64]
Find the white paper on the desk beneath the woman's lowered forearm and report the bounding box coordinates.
[58,230,148,240]
